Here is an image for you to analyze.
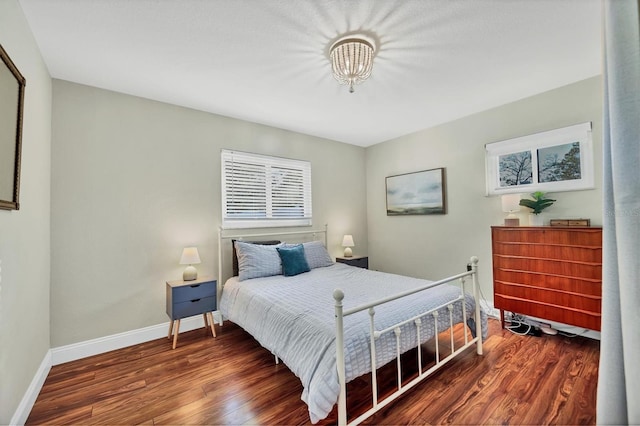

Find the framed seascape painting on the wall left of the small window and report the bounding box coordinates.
[386,168,447,216]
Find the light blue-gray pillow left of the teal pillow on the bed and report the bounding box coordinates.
[235,241,282,281]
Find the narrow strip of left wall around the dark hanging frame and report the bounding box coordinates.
[0,0,51,424]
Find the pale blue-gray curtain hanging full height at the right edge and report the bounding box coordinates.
[596,0,640,425]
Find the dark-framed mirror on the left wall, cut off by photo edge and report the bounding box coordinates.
[0,45,26,210]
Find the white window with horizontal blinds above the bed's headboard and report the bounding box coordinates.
[221,150,311,228]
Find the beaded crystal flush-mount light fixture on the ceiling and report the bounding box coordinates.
[329,36,375,93]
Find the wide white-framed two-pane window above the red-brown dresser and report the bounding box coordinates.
[485,122,594,195]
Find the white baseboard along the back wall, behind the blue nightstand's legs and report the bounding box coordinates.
[51,315,210,365]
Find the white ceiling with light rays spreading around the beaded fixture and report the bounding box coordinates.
[20,0,601,146]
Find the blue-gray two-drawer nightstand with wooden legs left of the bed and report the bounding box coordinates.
[166,277,217,349]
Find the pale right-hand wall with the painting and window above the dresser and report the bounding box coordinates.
[366,77,602,305]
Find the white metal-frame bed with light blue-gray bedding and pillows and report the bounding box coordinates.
[219,230,487,424]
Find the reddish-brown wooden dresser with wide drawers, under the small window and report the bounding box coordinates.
[491,226,602,331]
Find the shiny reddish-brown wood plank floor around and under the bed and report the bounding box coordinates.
[27,320,599,425]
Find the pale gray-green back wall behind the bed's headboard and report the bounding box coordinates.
[51,80,367,347]
